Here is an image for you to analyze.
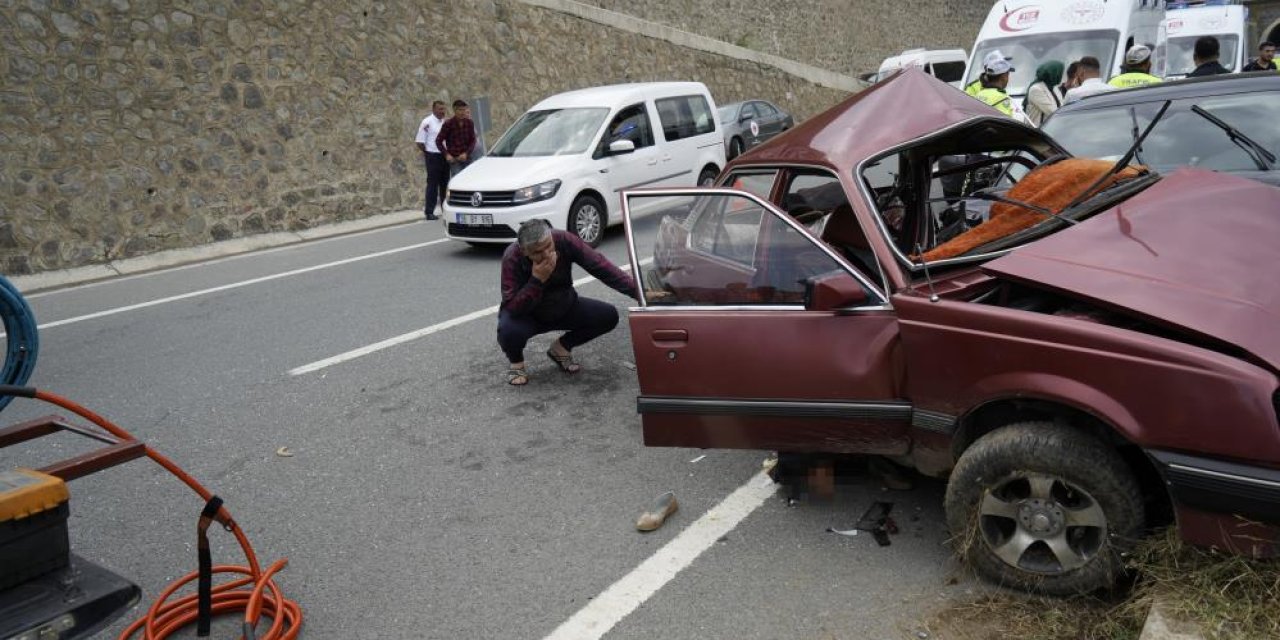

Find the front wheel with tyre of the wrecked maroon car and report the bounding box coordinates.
[946,422,1143,595]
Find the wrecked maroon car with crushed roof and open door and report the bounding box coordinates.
[623,70,1280,594]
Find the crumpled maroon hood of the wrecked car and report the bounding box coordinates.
[983,169,1280,370]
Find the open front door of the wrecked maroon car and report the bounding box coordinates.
[622,188,911,453]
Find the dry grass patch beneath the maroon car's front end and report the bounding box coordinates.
[927,529,1280,640]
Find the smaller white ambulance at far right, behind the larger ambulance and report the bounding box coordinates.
[1151,3,1249,79]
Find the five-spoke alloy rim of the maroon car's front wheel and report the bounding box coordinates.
[978,472,1107,575]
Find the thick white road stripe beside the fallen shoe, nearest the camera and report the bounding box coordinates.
[544,471,777,640]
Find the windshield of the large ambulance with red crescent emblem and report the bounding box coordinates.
[965,29,1120,96]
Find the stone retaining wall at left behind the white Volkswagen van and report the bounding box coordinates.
[0,0,860,275]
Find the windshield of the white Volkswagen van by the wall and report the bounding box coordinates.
[489,108,609,157]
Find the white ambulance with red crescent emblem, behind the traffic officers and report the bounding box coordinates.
[965,0,1165,97]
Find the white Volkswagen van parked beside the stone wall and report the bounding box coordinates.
[443,82,724,246]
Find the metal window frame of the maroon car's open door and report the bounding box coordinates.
[622,187,892,312]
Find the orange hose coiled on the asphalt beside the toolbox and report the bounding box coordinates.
[36,389,302,640]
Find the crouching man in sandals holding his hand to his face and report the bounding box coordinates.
[498,220,639,387]
